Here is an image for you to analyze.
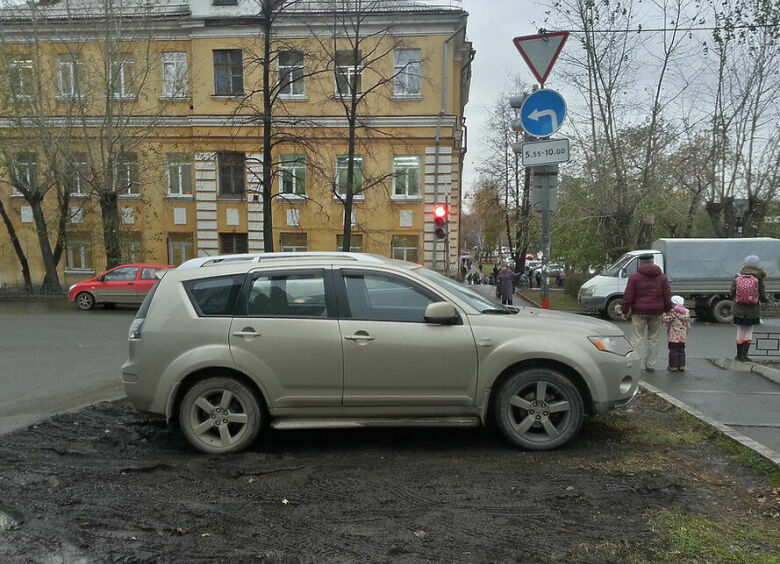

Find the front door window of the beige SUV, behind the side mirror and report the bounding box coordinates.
[344,273,438,323]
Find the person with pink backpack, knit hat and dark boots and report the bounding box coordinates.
[731,255,767,362]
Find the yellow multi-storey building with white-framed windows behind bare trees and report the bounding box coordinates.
[0,0,473,286]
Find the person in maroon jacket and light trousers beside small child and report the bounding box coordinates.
[621,253,673,372]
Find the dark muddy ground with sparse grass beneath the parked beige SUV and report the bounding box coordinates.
[0,395,780,563]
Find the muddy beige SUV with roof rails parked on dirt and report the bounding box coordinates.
[122,253,640,453]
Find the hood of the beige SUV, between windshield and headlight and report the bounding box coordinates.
[469,308,623,336]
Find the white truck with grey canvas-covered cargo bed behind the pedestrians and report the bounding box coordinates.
[577,237,780,323]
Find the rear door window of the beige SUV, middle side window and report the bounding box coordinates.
[245,273,328,317]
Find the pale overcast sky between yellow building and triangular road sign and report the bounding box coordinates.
[463,0,555,192]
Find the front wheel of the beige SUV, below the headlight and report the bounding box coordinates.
[494,368,585,450]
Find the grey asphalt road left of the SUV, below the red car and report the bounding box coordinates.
[0,302,135,433]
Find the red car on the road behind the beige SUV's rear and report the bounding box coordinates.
[68,264,173,310]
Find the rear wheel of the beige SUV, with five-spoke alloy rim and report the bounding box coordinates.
[179,377,263,454]
